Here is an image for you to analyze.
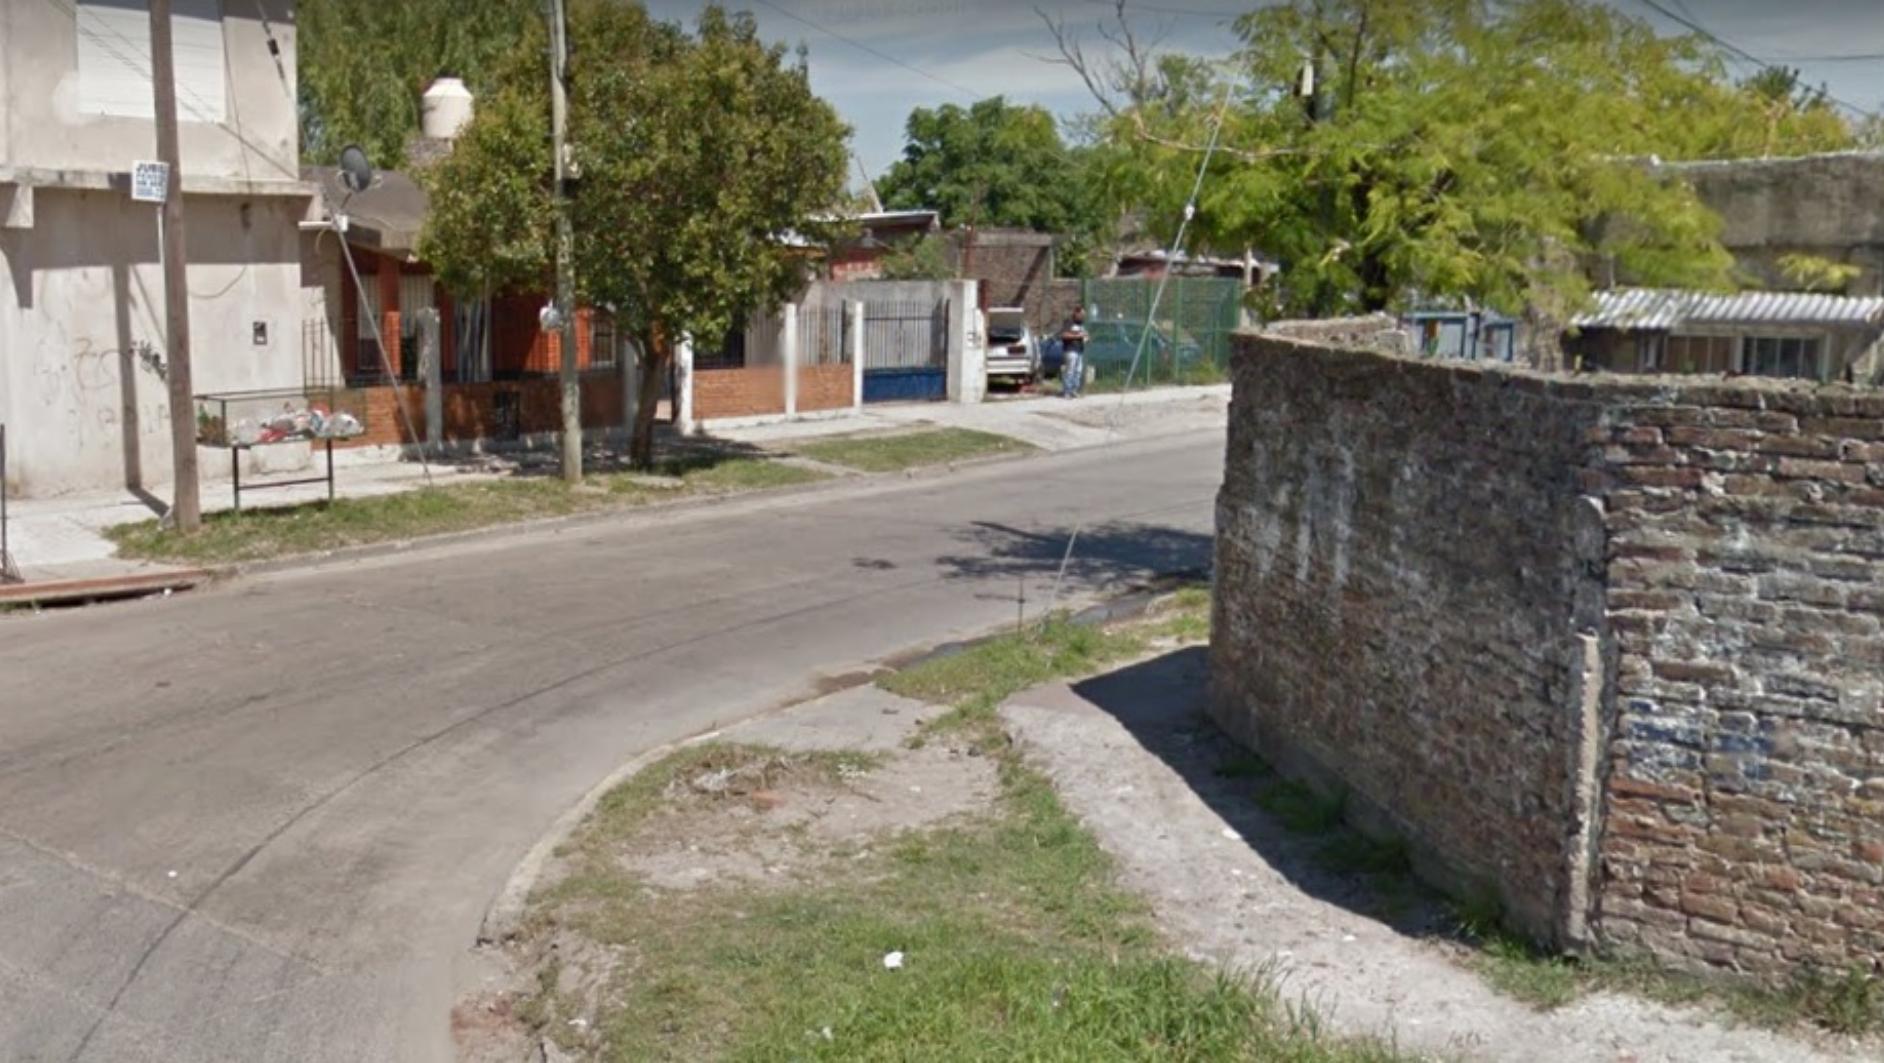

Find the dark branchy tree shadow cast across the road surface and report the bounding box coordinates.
[936,520,1211,590]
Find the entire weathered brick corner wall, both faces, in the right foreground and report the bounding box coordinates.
[1211,335,1884,973]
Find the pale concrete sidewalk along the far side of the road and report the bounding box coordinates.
[9,384,1230,582]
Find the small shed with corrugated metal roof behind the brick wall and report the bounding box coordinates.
[1564,288,1884,383]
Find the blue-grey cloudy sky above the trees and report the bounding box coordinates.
[646,0,1884,181]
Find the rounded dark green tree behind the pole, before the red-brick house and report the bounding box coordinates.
[420,0,848,467]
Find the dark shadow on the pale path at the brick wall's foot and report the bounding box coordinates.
[1072,646,1458,937]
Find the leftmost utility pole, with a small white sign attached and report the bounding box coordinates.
[151,0,203,532]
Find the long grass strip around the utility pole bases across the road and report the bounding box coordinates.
[106,456,825,565]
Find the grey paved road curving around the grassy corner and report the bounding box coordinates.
[0,432,1223,1063]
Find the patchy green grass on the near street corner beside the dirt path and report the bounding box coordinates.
[518,588,1396,1063]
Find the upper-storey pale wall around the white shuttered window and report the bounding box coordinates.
[0,0,300,181]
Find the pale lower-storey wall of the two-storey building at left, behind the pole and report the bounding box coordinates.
[0,188,303,496]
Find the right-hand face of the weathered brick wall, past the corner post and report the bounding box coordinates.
[1592,384,1884,971]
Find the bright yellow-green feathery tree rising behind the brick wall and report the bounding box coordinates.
[1063,0,1850,319]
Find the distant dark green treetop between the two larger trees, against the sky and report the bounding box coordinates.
[876,96,1110,273]
